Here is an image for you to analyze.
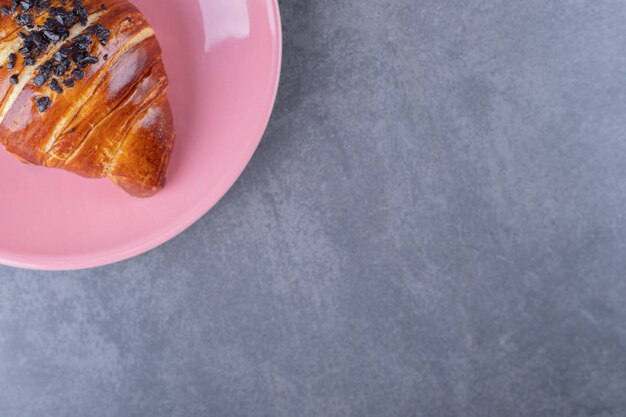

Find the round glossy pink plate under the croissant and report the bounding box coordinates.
[0,0,281,270]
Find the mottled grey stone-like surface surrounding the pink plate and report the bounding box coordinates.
[0,0,626,417]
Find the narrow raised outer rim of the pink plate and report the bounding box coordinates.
[0,0,283,271]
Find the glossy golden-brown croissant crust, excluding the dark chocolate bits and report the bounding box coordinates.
[0,0,175,197]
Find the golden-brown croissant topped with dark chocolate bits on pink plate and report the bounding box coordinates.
[0,0,175,197]
